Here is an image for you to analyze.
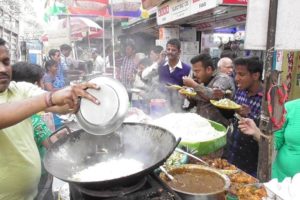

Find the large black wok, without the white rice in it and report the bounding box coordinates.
[44,123,179,190]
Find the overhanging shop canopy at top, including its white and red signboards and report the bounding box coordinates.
[157,0,247,30]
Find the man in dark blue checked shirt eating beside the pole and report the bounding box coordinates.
[224,57,263,176]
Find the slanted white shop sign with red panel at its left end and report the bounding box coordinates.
[156,0,218,25]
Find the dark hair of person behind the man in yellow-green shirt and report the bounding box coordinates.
[12,62,44,84]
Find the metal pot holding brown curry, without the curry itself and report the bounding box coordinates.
[160,164,230,200]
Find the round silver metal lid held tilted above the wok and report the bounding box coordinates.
[76,76,129,135]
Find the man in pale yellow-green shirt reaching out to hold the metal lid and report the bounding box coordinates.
[0,38,100,200]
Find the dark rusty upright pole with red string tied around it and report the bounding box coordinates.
[257,0,278,182]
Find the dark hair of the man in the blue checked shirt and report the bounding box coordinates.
[234,57,263,80]
